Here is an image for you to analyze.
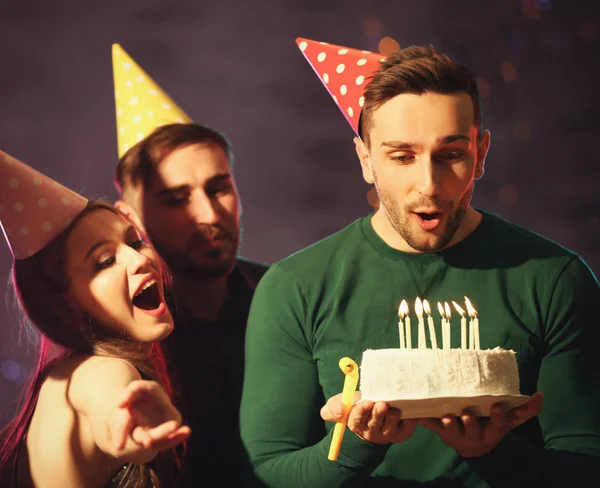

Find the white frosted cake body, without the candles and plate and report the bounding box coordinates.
[360,347,519,401]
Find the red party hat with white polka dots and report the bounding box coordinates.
[296,37,385,135]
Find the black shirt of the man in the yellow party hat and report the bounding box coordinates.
[165,258,267,487]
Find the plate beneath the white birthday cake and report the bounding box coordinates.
[360,395,531,419]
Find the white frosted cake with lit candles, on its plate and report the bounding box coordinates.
[360,297,528,418]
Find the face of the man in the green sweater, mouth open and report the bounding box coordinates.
[357,92,489,252]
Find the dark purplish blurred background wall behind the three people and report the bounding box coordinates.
[0,0,600,427]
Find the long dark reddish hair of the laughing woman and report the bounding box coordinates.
[0,201,179,487]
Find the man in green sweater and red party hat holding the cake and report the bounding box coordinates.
[241,40,600,488]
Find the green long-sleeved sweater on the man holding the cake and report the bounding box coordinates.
[241,212,600,488]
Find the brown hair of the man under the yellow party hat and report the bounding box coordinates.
[113,124,233,195]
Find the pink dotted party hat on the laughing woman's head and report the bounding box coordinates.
[0,151,88,259]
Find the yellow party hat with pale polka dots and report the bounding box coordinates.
[112,44,192,158]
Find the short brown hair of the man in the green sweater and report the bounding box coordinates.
[359,46,482,146]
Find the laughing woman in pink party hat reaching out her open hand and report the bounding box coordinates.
[0,151,190,488]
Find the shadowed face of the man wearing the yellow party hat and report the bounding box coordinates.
[136,144,240,279]
